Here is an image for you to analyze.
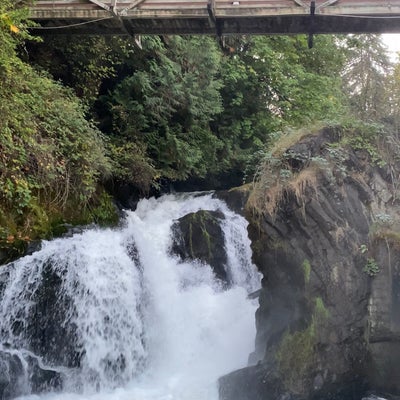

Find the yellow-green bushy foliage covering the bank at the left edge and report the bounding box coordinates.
[0,2,110,247]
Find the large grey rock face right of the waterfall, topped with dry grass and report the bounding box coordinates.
[220,130,400,400]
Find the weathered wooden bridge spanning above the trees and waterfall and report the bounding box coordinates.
[31,0,400,36]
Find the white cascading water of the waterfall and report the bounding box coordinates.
[0,194,260,400]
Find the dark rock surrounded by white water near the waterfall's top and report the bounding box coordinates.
[171,210,230,285]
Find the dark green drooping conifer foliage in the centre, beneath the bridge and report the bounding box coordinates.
[102,36,222,183]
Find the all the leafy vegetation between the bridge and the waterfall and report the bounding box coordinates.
[0,0,400,262]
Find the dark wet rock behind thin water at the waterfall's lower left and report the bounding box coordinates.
[0,263,71,399]
